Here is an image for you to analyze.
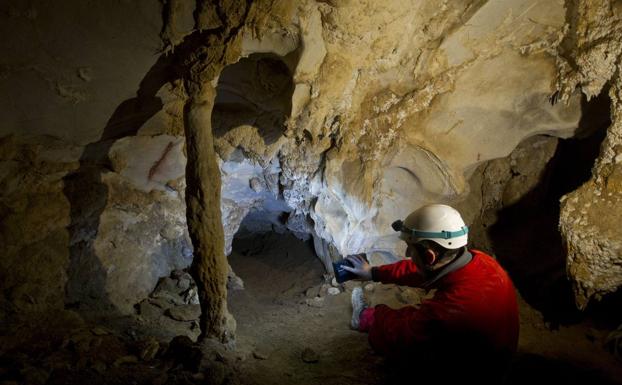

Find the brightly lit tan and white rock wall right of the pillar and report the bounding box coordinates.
[217,1,580,270]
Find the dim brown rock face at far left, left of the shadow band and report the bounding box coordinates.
[0,136,79,310]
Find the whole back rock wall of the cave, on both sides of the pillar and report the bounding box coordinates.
[0,0,620,312]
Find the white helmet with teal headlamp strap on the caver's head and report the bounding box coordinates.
[391,204,469,249]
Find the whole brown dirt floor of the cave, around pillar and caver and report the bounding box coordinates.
[0,233,622,385]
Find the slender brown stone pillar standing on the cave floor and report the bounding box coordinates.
[184,83,235,343]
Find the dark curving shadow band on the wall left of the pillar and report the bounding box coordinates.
[63,55,174,310]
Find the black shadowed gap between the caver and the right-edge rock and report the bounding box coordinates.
[489,90,611,326]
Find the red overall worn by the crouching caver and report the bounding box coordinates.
[361,250,519,378]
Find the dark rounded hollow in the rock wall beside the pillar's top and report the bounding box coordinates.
[212,54,294,145]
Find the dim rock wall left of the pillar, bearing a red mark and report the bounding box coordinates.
[0,0,194,312]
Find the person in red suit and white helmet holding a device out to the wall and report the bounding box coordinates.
[344,204,519,383]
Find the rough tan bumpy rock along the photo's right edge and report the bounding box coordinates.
[558,1,622,308]
